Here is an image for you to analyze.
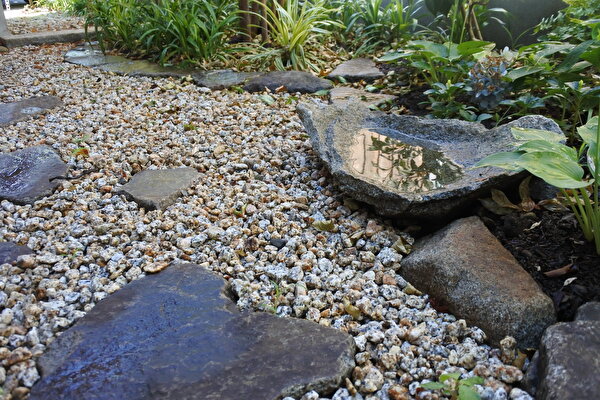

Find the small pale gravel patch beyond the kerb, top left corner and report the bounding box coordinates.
[4,7,83,35]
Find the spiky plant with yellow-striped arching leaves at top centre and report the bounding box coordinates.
[245,0,342,71]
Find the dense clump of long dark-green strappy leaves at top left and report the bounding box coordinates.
[85,0,238,64]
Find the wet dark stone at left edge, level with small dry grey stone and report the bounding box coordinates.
[0,146,69,204]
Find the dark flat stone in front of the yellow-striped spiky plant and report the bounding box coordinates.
[244,71,333,93]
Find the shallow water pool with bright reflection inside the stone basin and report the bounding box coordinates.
[348,129,463,193]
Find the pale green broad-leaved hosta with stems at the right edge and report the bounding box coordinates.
[476,116,600,254]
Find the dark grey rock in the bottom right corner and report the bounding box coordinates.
[525,303,600,400]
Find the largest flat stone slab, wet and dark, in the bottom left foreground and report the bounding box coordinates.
[30,264,354,400]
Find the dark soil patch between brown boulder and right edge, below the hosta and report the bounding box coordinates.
[479,209,600,321]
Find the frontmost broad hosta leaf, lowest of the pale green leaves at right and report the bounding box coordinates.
[518,152,591,189]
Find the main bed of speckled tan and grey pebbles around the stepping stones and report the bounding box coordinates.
[0,45,531,400]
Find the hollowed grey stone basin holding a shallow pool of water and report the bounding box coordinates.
[298,101,561,223]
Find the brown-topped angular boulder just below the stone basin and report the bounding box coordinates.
[401,217,556,348]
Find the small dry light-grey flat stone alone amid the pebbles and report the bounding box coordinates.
[117,168,200,210]
